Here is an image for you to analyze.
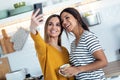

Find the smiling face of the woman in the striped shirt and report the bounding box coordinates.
[61,12,78,32]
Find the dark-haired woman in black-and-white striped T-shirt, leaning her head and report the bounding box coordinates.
[60,8,108,80]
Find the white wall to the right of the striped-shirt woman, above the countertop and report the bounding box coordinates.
[84,0,120,62]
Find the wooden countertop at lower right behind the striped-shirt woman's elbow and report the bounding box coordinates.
[103,60,120,78]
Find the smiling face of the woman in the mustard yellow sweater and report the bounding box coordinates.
[47,17,61,37]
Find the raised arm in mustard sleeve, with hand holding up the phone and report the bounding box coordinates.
[30,9,46,54]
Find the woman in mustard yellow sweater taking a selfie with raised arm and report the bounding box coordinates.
[30,9,74,80]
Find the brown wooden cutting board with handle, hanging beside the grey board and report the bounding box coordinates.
[0,29,15,54]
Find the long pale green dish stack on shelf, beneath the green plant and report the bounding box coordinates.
[9,5,33,16]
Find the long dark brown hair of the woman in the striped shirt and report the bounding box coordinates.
[60,7,89,31]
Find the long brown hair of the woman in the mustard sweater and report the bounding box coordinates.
[44,14,63,46]
